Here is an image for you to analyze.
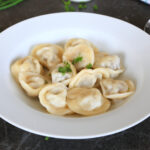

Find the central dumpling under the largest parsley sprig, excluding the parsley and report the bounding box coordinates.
[51,61,76,85]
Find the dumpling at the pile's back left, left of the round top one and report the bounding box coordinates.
[31,44,63,70]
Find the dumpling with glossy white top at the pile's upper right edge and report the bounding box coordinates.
[93,53,124,78]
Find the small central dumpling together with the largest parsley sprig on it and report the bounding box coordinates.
[51,62,76,85]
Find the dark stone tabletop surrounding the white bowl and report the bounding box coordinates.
[0,0,150,150]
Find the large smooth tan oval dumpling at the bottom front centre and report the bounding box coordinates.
[67,88,111,116]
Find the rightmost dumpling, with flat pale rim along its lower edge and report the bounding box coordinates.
[100,79,135,99]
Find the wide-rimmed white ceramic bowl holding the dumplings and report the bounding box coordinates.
[0,13,150,139]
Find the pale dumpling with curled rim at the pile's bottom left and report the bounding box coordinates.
[39,83,72,115]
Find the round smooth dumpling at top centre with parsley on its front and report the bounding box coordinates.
[63,44,94,71]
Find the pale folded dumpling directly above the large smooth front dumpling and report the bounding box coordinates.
[69,69,97,88]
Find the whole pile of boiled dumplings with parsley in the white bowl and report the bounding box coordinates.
[11,38,135,116]
